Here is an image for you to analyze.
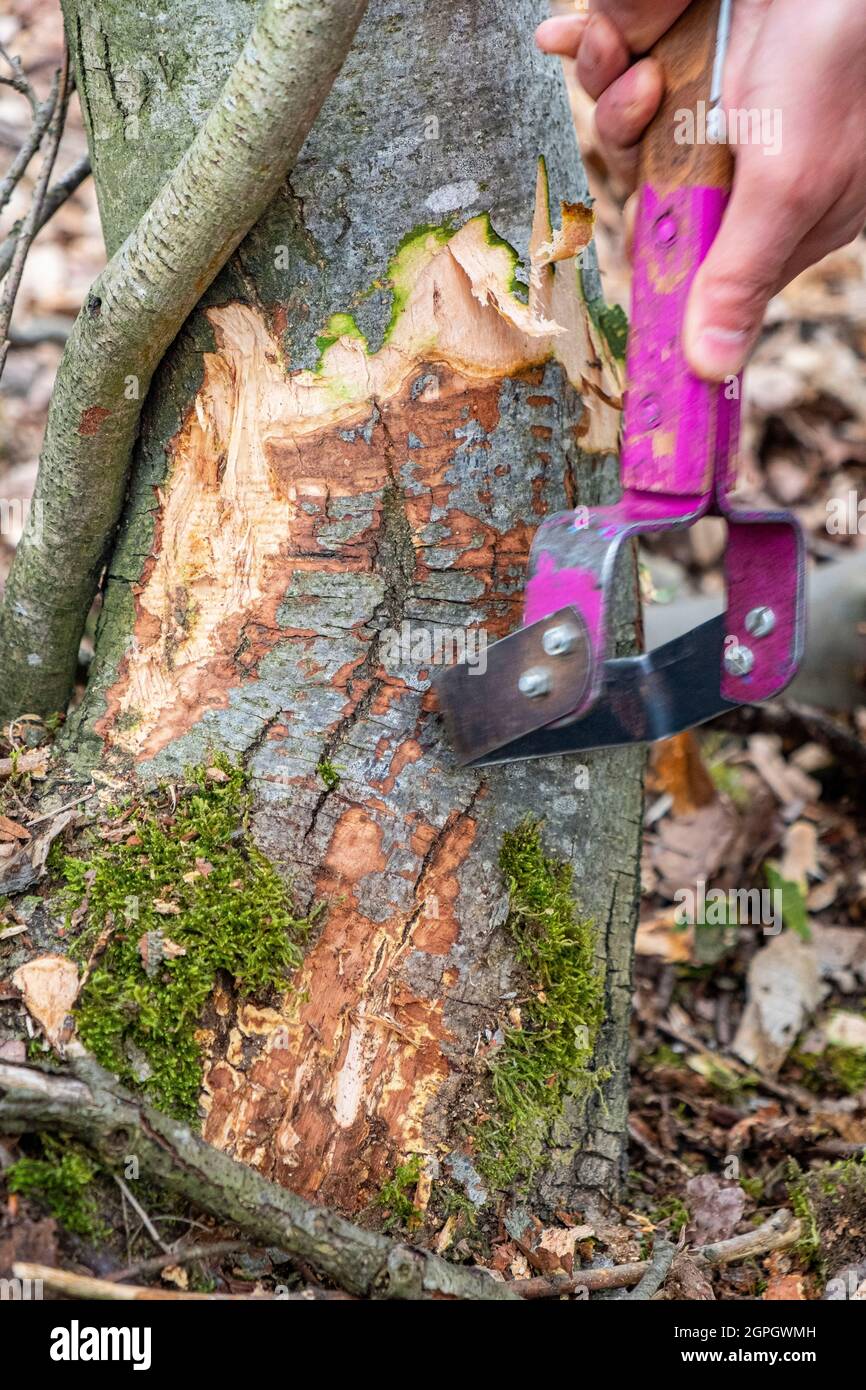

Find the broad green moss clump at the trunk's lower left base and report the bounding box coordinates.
[63,759,310,1119]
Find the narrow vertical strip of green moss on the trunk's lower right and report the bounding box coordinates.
[474,820,606,1188]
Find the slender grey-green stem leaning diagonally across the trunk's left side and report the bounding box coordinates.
[0,0,366,716]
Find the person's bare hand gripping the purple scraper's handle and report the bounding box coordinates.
[537,0,866,381]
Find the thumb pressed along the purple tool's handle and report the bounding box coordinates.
[684,146,808,381]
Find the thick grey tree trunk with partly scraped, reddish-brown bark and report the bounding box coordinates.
[64,0,642,1212]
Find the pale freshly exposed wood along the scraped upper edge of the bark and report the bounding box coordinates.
[99,177,620,758]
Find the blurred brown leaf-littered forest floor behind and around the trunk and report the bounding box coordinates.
[0,0,866,1300]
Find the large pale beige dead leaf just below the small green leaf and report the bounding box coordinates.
[733,931,827,1076]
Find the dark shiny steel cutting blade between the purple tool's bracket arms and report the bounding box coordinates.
[470,614,738,767]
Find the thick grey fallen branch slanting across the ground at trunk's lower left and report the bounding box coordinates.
[0,1058,518,1301]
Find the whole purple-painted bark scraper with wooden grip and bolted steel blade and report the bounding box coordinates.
[435,0,805,766]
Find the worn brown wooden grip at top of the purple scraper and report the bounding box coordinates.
[639,0,733,192]
